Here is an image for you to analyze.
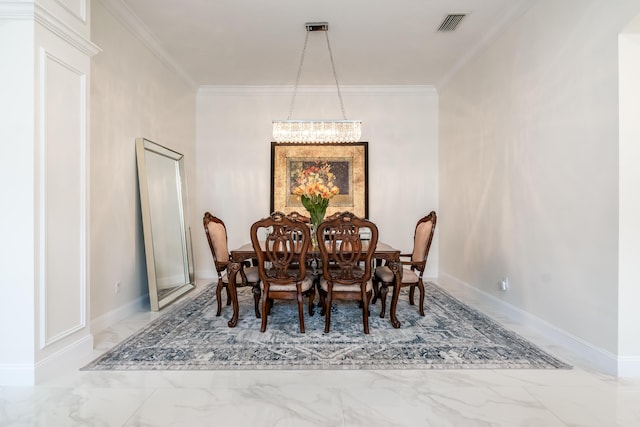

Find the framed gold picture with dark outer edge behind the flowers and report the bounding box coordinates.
[270,142,369,218]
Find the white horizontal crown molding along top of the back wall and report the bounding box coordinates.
[198,85,438,96]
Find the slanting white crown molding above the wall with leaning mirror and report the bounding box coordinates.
[98,0,198,88]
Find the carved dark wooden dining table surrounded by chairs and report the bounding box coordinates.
[227,240,402,328]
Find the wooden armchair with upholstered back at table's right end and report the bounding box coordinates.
[371,211,437,317]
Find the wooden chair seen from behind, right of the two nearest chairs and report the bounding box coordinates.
[317,212,378,334]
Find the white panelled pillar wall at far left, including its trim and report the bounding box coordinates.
[0,1,97,385]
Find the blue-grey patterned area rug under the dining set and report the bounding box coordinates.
[83,283,570,370]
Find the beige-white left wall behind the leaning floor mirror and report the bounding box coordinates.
[90,1,197,327]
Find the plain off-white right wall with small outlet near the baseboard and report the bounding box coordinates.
[439,0,640,370]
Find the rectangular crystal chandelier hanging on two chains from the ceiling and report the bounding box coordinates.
[273,22,362,143]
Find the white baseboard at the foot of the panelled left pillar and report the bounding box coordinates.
[0,334,93,386]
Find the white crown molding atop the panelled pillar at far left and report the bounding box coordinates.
[0,2,101,56]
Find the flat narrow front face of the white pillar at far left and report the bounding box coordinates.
[0,10,36,384]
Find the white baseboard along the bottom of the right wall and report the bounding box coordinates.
[437,272,640,377]
